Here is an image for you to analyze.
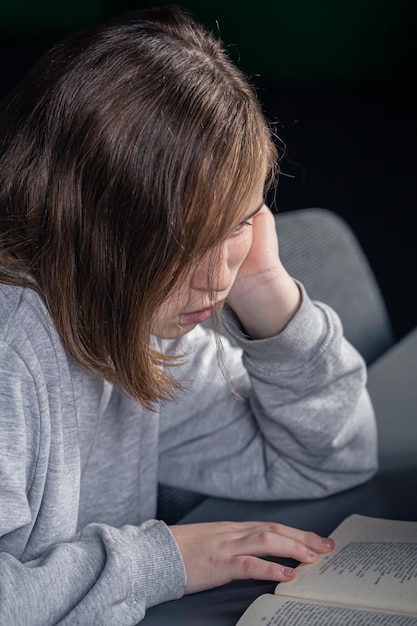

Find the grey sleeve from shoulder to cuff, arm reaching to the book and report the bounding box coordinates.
[0,341,185,626]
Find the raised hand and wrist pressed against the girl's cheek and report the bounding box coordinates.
[227,205,301,339]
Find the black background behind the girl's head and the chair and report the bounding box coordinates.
[0,0,417,339]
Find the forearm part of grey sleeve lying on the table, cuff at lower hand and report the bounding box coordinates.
[0,520,185,626]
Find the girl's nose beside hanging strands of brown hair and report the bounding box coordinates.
[191,241,235,292]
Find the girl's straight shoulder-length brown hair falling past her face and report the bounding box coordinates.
[0,7,276,406]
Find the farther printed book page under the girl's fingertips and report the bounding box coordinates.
[275,515,417,616]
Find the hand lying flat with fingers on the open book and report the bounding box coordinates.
[170,522,334,593]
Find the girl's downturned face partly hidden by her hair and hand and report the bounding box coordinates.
[152,181,264,339]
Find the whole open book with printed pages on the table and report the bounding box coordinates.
[236,515,417,626]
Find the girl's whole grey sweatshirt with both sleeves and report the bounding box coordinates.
[0,285,376,626]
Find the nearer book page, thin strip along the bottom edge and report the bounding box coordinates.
[236,594,417,626]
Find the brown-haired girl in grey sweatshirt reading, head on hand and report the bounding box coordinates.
[0,8,376,626]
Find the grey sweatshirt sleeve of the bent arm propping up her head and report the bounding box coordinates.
[160,285,377,500]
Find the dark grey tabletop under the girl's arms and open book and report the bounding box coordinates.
[141,329,417,626]
